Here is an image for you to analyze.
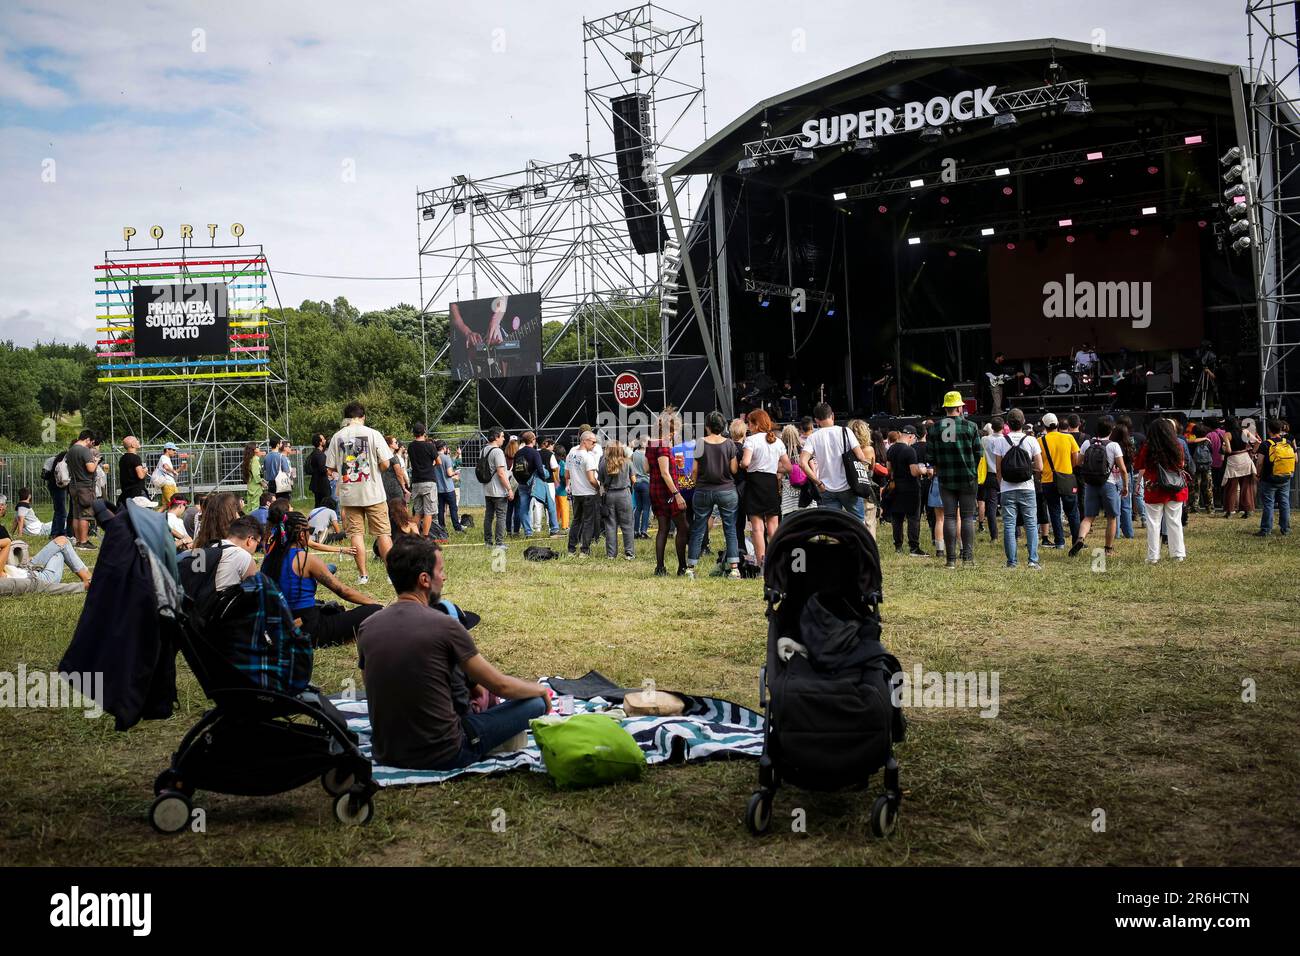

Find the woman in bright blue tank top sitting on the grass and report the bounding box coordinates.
[261,511,382,648]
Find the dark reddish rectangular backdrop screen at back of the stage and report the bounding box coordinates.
[988,221,1205,359]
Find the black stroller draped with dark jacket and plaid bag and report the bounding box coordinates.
[64,503,378,834]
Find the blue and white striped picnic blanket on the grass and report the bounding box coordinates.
[334,696,763,787]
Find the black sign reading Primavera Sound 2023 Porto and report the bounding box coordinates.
[133,282,230,358]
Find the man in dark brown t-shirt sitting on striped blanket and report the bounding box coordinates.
[356,535,550,770]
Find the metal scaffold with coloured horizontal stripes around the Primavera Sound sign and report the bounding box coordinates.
[95,245,289,481]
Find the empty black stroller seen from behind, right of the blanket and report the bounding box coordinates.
[745,509,906,836]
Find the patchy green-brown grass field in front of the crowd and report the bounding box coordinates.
[0,504,1300,866]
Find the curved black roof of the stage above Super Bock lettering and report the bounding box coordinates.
[668,38,1244,177]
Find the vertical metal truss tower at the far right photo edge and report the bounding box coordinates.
[1245,0,1300,416]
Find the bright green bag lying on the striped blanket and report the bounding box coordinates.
[532,714,646,790]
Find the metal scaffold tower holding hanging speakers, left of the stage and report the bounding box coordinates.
[416,4,709,431]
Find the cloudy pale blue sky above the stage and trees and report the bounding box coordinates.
[0,0,1247,345]
